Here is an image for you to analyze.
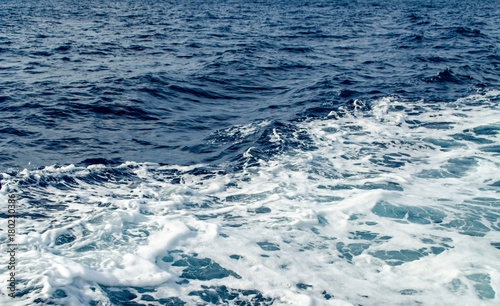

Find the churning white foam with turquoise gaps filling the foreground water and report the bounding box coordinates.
[0,91,500,305]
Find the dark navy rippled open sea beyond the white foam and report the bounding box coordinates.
[0,1,500,169]
